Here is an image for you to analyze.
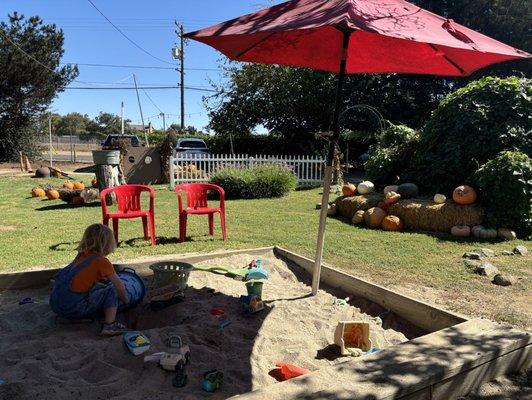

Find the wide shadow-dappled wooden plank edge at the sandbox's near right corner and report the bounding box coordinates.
[232,319,532,400]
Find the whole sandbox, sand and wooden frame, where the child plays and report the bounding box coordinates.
[0,247,531,400]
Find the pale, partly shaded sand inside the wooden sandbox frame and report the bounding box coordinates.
[0,255,408,400]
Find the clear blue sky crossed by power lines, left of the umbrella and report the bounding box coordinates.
[0,0,281,127]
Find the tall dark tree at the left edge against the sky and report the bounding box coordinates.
[0,13,78,161]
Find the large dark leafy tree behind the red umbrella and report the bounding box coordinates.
[206,0,532,152]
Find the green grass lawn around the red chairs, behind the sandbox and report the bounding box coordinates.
[0,176,532,327]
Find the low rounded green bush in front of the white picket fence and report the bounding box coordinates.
[211,164,297,199]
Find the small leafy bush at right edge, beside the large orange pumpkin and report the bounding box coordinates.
[472,151,532,237]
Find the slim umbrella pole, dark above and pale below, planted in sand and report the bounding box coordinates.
[312,31,351,296]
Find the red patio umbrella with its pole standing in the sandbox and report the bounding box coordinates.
[186,0,531,294]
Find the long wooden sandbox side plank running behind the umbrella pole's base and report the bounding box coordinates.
[274,246,469,332]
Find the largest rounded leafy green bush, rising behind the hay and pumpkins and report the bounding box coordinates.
[409,77,532,193]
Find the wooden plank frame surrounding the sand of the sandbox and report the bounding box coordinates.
[0,246,532,400]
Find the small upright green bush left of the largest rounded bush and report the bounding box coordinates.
[364,124,419,185]
